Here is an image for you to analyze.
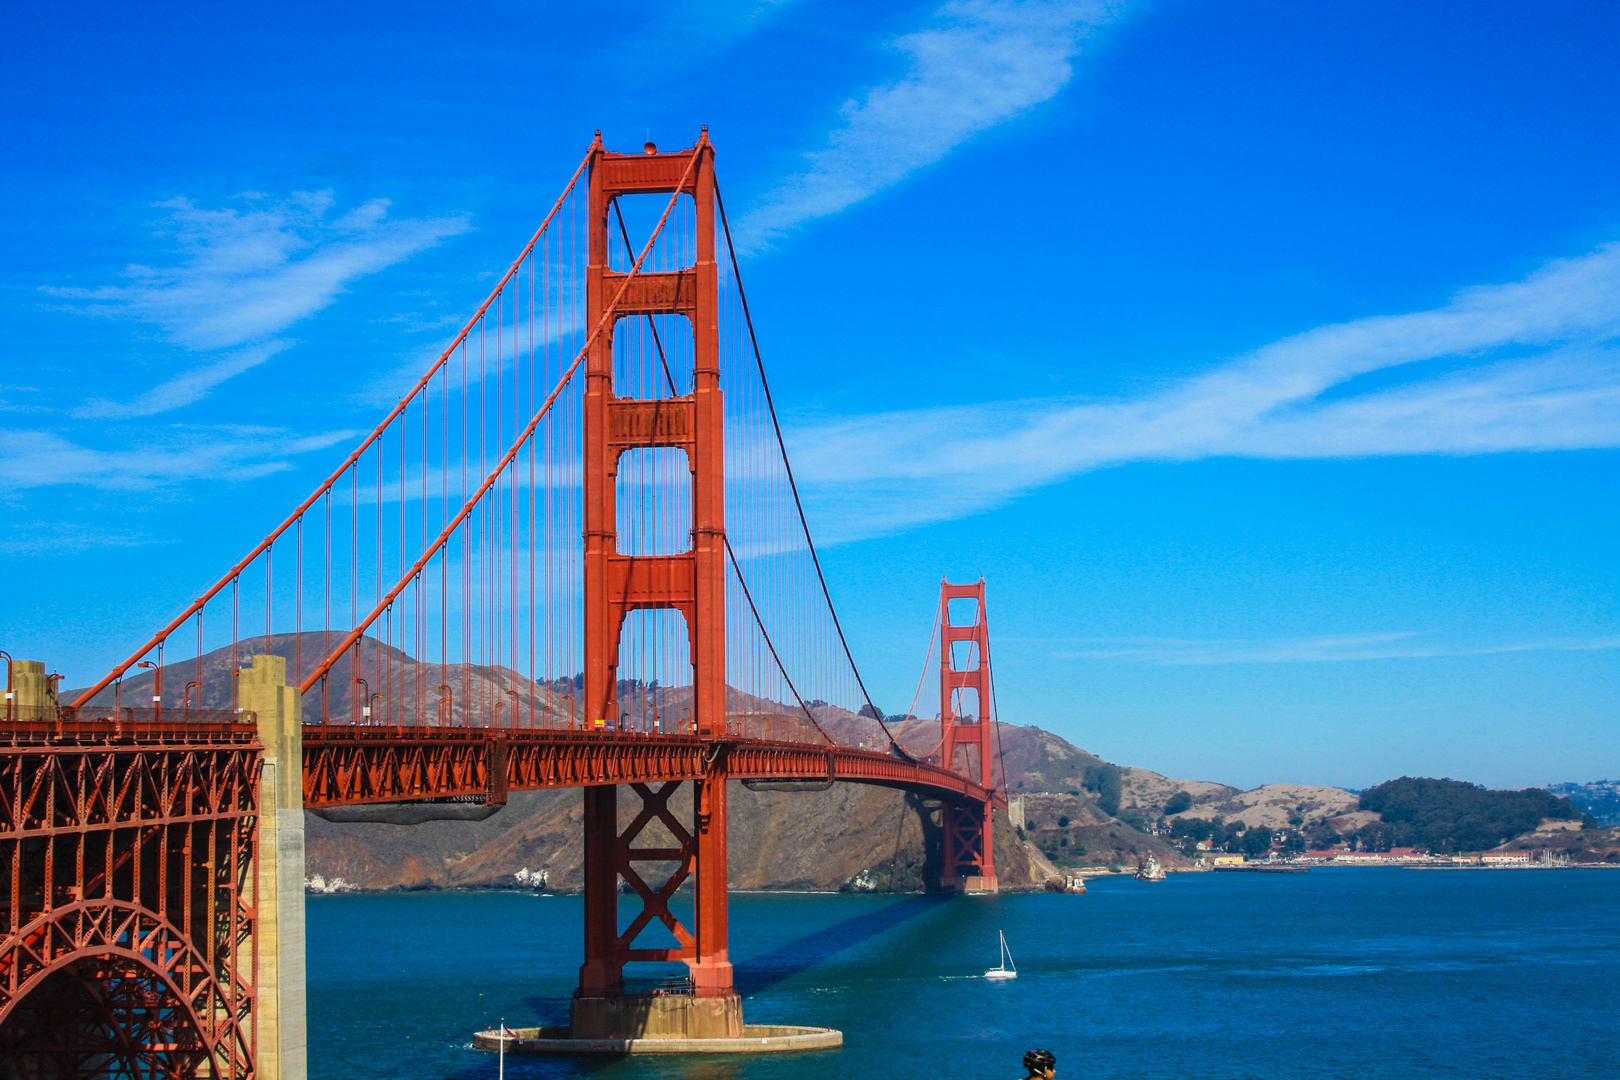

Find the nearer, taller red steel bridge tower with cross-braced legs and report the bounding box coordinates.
[580,137,735,996]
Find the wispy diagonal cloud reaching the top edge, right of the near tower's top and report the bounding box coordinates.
[739,0,1131,249]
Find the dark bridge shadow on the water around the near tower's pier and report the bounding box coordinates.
[442,895,948,1080]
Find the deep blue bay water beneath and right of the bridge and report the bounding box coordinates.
[308,870,1620,1080]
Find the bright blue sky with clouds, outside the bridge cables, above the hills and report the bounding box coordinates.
[0,0,1620,787]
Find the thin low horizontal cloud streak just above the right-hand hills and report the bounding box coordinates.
[1053,631,1620,667]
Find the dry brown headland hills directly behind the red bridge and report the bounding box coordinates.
[65,631,1192,891]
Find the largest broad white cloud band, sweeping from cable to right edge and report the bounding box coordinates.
[789,244,1620,539]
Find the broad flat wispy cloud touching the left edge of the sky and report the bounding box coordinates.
[0,427,360,492]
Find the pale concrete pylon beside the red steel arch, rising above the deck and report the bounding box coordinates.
[238,656,309,1080]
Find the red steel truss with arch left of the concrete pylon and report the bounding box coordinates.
[0,711,261,1080]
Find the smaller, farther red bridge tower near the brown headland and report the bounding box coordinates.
[940,578,996,886]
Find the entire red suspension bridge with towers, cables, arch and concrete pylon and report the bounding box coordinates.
[0,130,1004,1080]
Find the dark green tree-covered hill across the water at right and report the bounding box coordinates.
[1358,776,1581,852]
